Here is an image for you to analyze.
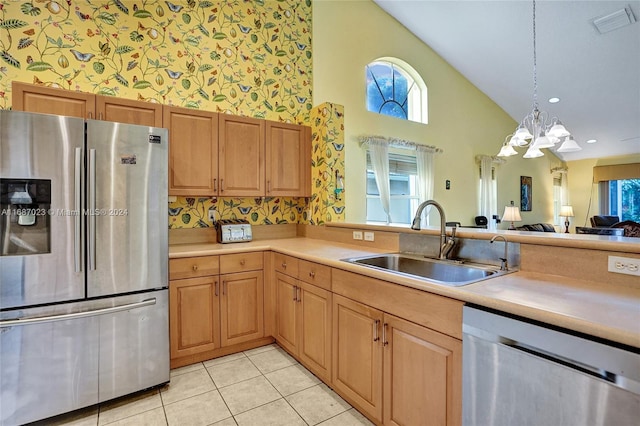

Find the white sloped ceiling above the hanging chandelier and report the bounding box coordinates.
[374,0,640,161]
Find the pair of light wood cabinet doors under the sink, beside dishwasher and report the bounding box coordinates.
[332,288,462,425]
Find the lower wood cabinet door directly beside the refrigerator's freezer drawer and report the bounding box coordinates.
[169,276,220,359]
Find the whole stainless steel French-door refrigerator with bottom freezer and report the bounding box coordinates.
[0,111,169,426]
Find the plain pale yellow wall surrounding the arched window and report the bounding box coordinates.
[313,0,572,228]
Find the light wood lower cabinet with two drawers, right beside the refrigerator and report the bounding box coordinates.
[169,252,266,367]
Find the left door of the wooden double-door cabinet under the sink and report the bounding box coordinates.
[332,294,382,421]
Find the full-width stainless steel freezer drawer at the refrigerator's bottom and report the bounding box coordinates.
[0,289,169,426]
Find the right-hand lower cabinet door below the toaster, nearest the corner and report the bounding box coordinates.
[220,271,264,346]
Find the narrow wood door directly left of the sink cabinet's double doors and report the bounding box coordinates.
[297,281,331,382]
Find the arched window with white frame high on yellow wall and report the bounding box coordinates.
[365,58,428,124]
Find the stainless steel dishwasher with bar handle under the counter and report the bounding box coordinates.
[462,306,640,426]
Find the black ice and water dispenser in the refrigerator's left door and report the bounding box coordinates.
[0,179,51,256]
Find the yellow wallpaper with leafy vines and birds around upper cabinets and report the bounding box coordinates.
[0,0,344,228]
